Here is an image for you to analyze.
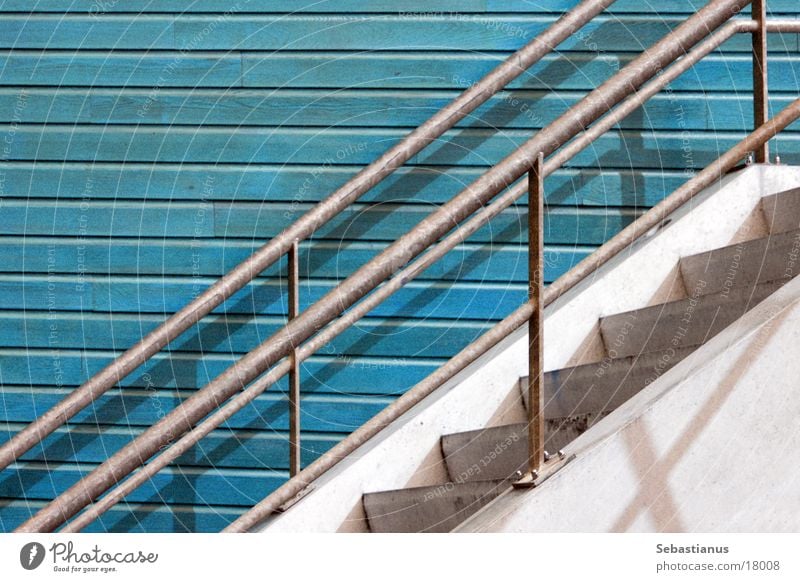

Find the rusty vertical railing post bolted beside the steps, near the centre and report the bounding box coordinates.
[528,152,544,478]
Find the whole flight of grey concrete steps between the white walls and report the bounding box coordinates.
[363,189,800,532]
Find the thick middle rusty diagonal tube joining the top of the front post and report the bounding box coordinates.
[18,0,750,531]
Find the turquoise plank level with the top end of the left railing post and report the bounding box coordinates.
[0,237,594,282]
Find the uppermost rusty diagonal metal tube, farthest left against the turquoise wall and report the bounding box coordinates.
[0,0,616,480]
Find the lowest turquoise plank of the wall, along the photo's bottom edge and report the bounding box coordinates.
[0,499,246,533]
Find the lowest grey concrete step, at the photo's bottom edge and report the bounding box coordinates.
[363,481,510,533]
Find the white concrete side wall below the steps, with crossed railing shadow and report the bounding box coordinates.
[458,278,800,532]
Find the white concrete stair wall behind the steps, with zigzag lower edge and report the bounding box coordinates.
[259,166,800,532]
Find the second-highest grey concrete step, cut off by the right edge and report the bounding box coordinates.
[680,230,800,295]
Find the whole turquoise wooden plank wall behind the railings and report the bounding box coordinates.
[0,0,800,531]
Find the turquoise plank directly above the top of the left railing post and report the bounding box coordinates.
[0,199,639,245]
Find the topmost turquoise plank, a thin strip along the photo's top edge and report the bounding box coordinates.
[0,0,796,14]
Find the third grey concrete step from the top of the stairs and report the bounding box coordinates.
[600,279,788,357]
